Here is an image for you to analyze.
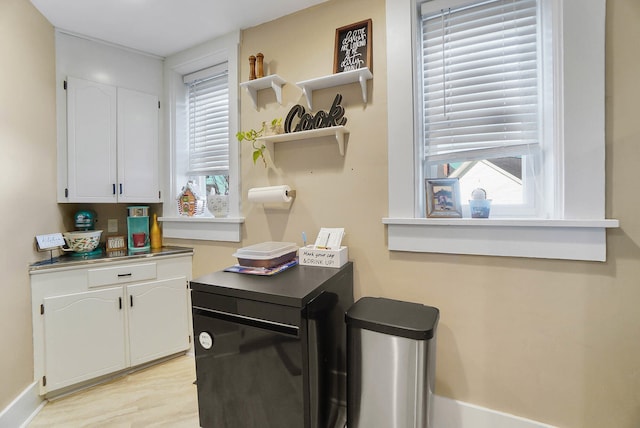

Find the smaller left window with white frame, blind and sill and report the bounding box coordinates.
[160,32,244,242]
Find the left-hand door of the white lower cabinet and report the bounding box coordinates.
[43,287,126,391]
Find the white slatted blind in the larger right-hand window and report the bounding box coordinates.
[422,0,539,165]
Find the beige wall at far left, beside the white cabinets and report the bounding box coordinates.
[0,0,60,410]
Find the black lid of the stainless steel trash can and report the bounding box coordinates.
[345,297,440,340]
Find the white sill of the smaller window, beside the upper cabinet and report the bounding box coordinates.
[158,217,244,242]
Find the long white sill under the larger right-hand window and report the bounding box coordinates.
[382,218,619,261]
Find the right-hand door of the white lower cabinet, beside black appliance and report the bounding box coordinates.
[126,276,190,366]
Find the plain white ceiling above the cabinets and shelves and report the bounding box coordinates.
[31,0,326,57]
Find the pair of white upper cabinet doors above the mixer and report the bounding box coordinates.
[63,77,161,203]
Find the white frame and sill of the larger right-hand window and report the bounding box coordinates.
[382,0,619,261]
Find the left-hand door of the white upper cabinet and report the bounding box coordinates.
[67,77,117,202]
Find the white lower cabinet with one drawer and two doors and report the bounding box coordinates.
[30,254,191,395]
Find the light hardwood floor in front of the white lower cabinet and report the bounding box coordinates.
[28,355,199,428]
